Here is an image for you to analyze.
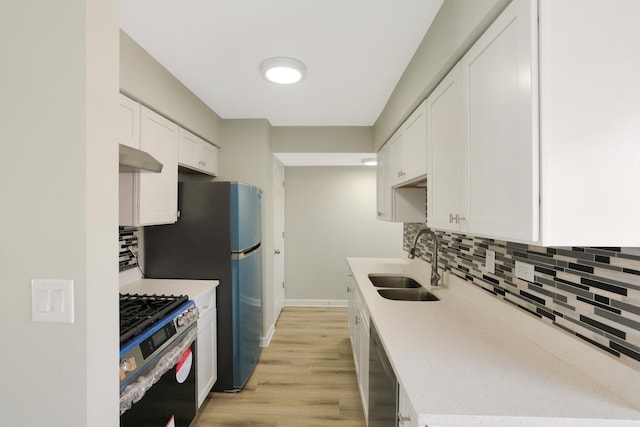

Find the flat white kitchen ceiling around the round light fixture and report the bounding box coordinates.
[120,0,443,126]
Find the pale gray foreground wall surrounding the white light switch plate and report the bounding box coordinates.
[0,0,118,427]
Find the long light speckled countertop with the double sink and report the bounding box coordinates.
[347,258,640,427]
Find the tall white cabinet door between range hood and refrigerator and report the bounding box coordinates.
[138,106,178,225]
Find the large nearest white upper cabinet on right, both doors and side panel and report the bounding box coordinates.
[427,0,640,246]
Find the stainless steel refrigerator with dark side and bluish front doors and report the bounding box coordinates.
[144,182,262,391]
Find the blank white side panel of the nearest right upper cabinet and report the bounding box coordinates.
[539,0,640,246]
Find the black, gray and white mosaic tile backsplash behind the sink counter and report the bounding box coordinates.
[403,223,640,370]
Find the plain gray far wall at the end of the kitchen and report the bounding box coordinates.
[285,167,402,305]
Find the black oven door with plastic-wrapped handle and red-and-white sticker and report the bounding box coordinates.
[120,324,198,427]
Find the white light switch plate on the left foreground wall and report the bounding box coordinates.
[31,279,74,323]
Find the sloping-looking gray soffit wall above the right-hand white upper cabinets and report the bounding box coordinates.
[374,0,511,150]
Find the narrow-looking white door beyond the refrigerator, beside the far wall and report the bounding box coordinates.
[273,158,284,319]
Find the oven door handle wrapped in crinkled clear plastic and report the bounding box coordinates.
[120,323,198,415]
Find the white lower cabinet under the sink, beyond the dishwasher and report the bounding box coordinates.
[347,276,369,419]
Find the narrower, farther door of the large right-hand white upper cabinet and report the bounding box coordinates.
[426,65,469,232]
